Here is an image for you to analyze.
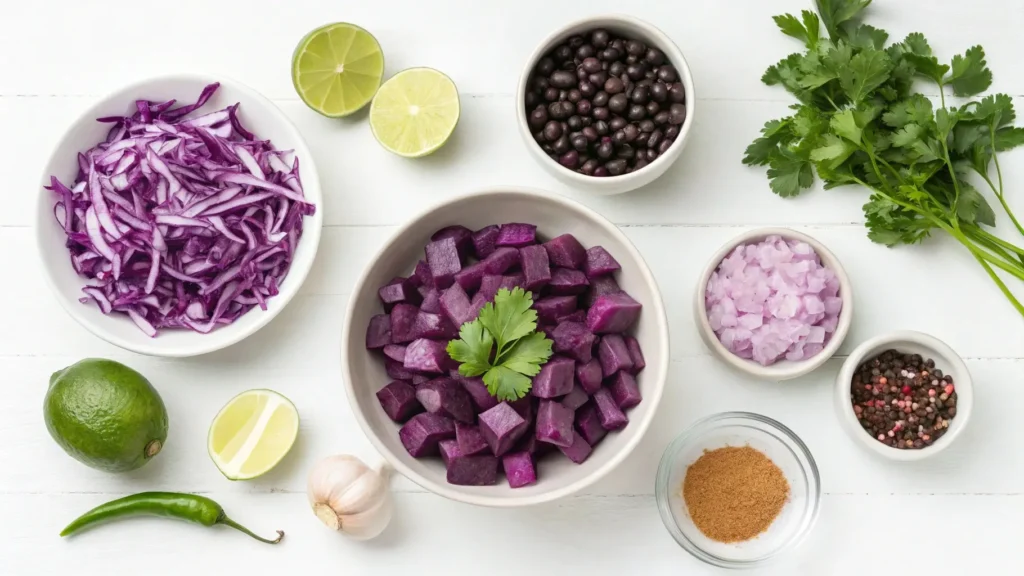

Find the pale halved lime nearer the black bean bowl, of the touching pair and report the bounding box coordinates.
[370,68,461,158]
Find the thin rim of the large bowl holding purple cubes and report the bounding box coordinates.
[341,186,670,507]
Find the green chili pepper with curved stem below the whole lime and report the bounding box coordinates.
[60,492,285,544]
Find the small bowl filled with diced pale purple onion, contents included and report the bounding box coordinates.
[693,228,853,380]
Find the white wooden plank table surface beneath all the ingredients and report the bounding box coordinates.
[0,0,1024,576]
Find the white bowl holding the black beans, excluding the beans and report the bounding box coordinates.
[515,14,697,196]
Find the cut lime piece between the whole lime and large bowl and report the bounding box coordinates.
[207,389,299,480]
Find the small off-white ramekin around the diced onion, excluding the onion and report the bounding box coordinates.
[693,228,853,380]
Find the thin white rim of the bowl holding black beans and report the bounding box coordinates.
[515,13,696,187]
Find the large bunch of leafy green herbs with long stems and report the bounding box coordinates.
[743,0,1024,315]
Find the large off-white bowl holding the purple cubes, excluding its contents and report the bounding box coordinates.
[341,187,669,507]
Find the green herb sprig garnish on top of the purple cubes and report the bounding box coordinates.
[447,288,553,401]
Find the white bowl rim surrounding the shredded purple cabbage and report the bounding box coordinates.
[35,73,324,358]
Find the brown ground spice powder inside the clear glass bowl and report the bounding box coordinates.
[683,446,790,542]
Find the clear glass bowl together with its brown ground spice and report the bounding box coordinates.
[655,412,821,569]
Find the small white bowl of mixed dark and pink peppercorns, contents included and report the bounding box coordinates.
[836,331,974,461]
